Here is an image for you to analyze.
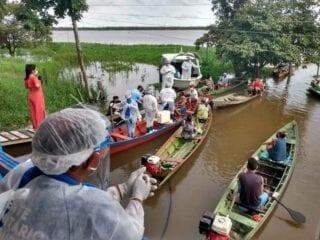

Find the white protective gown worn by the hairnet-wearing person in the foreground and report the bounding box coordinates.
[0,161,144,240]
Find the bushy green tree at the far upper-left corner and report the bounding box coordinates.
[0,3,51,56]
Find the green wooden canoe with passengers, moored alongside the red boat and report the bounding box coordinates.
[147,111,212,189]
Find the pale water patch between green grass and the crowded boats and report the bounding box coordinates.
[60,62,159,100]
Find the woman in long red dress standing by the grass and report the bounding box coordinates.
[24,64,46,129]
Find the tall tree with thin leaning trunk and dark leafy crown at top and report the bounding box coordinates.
[22,0,92,99]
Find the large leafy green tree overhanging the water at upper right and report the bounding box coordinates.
[197,0,317,75]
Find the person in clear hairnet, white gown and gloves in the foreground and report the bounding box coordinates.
[0,109,156,240]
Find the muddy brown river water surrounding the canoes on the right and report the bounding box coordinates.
[4,66,320,240]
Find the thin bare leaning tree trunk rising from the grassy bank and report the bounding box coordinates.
[72,19,92,100]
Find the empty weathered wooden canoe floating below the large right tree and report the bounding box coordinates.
[213,93,260,108]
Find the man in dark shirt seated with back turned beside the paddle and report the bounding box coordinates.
[237,158,269,209]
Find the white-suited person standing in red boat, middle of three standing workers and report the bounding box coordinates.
[142,87,159,133]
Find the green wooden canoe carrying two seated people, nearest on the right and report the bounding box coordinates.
[206,121,299,240]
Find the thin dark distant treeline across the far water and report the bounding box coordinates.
[53,26,209,31]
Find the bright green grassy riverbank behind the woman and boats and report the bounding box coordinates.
[0,43,231,130]
